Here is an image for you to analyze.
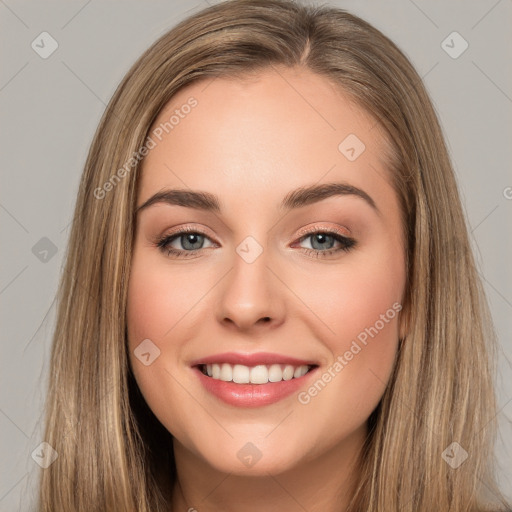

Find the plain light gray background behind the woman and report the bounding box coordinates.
[0,0,512,512]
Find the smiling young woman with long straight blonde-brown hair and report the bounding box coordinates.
[40,0,507,512]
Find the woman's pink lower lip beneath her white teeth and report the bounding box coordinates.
[193,366,318,407]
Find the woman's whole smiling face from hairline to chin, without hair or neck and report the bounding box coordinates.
[127,68,405,475]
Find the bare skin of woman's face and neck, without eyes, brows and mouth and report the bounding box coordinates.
[127,68,405,512]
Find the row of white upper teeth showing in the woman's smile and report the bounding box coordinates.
[203,363,309,384]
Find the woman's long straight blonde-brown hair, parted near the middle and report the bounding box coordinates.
[39,0,505,512]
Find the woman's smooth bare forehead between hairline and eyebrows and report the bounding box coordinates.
[138,68,394,214]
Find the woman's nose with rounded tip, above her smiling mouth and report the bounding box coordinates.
[217,247,285,332]
